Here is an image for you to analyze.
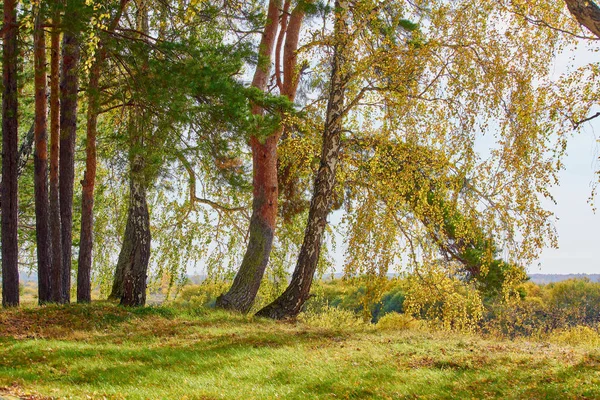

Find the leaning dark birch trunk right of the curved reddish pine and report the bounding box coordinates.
[257,0,348,319]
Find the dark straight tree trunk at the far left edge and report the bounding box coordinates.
[2,0,19,307]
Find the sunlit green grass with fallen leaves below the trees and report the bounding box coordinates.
[0,303,600,399]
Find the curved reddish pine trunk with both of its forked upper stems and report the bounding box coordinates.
[217,0,311,312]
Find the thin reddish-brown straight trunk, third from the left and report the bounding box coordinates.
[50,11,63,303]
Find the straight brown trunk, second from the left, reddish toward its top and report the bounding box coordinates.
[33,8,51,304]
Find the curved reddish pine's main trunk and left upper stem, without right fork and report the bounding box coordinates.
[217,0,281,312]
